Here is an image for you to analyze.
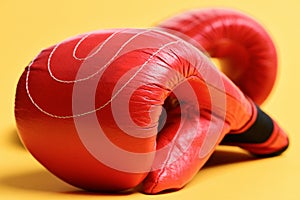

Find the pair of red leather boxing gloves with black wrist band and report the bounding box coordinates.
[15,9,289,194]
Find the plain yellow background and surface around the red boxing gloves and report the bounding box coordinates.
[0,0,300,200]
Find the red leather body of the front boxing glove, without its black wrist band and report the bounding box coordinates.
[15,29,288,194]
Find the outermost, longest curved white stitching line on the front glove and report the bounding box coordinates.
[26,31,181,119]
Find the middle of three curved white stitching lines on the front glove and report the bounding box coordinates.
[47,29,151,83]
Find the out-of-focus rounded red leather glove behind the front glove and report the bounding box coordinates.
[159,8,277,105]
